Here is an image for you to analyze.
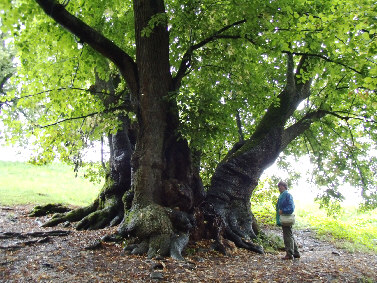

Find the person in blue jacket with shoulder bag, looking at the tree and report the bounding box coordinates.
[276,181,300,260]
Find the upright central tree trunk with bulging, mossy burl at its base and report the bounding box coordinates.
[118,0,206,258]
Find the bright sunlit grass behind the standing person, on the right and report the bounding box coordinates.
[251,193,377,253]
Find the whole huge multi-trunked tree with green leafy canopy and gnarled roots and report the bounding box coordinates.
[2,0,377,258]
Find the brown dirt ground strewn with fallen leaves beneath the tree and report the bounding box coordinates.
[0,207,377,283]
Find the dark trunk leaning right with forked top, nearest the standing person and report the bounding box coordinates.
[206,54,324,252]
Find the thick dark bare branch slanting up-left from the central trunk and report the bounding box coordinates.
[35,0,138,93]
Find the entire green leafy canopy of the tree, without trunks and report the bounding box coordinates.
[1,0,377,208]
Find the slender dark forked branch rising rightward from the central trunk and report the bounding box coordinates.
[173,20,246,89]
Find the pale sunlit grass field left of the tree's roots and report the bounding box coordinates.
[0,161,101,206]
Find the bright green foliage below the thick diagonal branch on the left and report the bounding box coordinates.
[2,1,124,171]
